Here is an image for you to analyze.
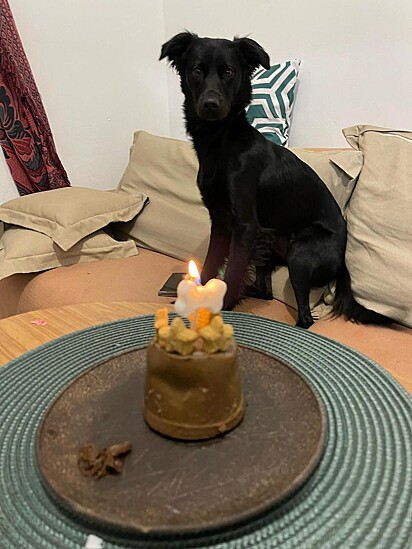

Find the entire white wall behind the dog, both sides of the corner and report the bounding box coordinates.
[0,0,412,201]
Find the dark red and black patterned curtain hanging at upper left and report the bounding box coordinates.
[0,0,70,195]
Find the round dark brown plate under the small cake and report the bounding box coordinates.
[36,347,326,535]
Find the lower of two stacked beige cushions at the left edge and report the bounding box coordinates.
[0,225,137,280]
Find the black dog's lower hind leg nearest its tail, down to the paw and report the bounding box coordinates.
[287,241,313,328]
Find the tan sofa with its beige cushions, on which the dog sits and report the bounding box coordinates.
[0,125,412,391]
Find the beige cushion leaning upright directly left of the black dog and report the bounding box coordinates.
[117,131,210,261]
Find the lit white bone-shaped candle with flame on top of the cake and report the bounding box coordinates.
[175,261,227,318]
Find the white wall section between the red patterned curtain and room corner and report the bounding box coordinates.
[4,0,169,195]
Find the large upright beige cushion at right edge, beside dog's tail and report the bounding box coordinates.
[344,126,412,327]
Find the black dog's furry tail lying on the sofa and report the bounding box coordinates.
[333,262,393,324]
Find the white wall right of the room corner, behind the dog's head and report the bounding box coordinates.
[164,0,412,147]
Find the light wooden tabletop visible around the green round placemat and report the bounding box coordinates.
[0,302,412,394]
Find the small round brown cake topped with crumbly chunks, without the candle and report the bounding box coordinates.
[144,310,244,440]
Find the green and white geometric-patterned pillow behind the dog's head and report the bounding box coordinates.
[246,59,300,146]
